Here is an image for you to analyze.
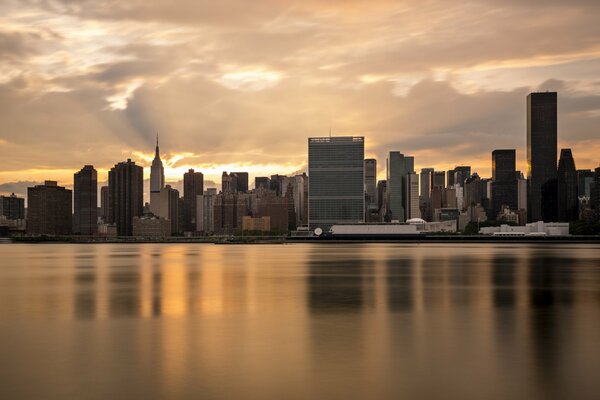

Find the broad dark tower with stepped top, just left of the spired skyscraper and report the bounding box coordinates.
[108,159,144,236]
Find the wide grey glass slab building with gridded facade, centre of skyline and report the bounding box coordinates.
[310,136,365,230]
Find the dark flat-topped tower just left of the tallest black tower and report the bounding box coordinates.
[491,149,519,219]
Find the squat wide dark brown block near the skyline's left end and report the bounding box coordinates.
[27,181,73,235]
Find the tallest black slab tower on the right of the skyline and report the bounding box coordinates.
[527,92,558,222]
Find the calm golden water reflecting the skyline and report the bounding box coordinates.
[0,244,600,399]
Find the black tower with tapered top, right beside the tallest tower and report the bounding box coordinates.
[558,149,579,222]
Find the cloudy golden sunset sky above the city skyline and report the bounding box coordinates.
[0,0,600,198]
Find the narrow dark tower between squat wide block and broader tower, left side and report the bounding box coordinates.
[73,165,98,235]
